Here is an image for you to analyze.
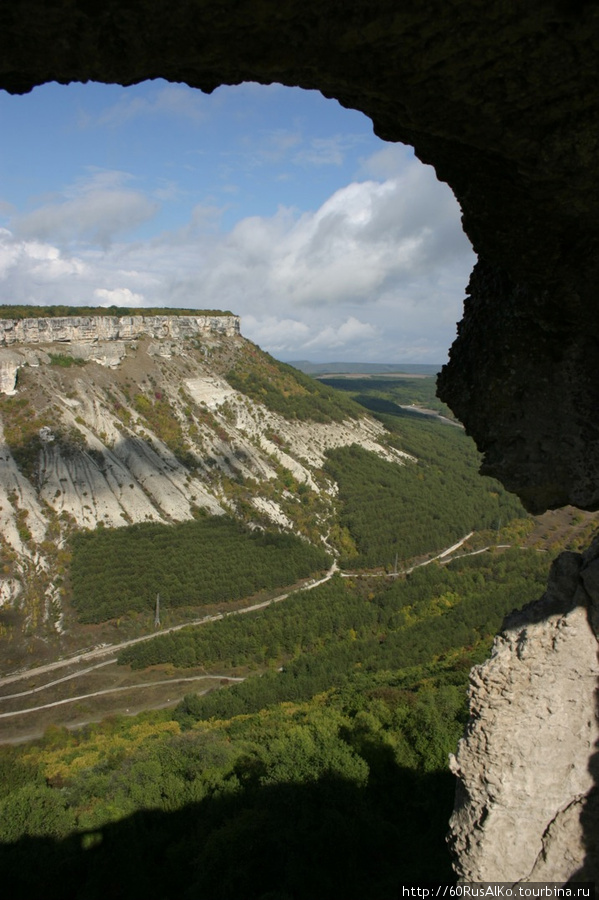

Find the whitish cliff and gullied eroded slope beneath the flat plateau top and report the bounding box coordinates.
[0,316,408,652]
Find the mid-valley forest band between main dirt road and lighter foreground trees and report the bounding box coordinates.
[119,549,547,700]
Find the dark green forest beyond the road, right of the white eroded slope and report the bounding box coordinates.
[310,377,527,570]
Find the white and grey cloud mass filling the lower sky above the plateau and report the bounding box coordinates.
[0,157,474,362]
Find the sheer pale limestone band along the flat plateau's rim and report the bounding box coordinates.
[0,316,240,346]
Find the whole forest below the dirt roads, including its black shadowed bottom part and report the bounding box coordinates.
[0,550,549,900]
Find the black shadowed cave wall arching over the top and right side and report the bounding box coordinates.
[0,0,599,880]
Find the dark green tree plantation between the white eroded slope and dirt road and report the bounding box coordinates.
[70,516,330,622]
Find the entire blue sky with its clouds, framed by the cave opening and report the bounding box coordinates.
[0,81,474,362]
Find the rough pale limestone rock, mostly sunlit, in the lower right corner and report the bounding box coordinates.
[450,544,599,882]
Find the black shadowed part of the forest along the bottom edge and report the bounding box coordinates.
[0,768,454,900]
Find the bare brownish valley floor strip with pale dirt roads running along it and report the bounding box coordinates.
[0,510,584,744]
